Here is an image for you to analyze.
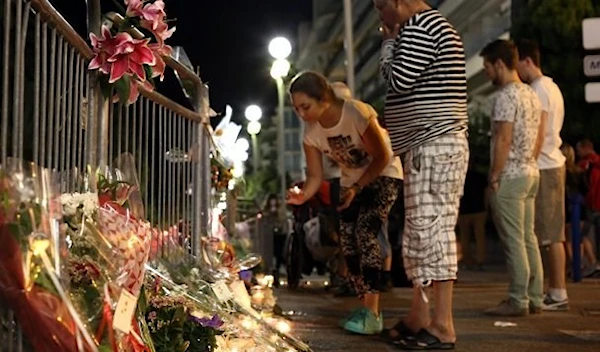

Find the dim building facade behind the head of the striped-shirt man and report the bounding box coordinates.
[296,0,511,107]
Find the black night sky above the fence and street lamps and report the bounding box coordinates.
[50,0,312,122]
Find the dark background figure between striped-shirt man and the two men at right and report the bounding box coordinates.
[458,159,489,270]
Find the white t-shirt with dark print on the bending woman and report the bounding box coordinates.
[304,100,404,187]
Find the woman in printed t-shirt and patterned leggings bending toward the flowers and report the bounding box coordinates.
[288,72,403,335]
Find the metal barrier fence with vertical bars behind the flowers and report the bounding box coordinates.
[0,0,211,352]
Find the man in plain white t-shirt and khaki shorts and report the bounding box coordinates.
[517,40,569,311]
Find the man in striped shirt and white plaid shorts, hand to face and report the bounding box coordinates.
[373,0,469,349]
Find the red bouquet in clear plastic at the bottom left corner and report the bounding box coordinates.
[0,160,96,352]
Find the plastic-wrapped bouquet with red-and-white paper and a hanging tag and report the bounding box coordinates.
[61,166,153,351]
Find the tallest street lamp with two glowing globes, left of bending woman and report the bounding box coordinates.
[269,37,292,204]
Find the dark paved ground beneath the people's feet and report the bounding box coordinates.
[277,268,600,352]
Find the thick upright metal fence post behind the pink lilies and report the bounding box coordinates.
[85,0,112,170]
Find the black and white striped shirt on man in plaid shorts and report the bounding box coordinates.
[381,10,468,155]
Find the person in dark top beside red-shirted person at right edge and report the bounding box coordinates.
[560,143,600,277]
